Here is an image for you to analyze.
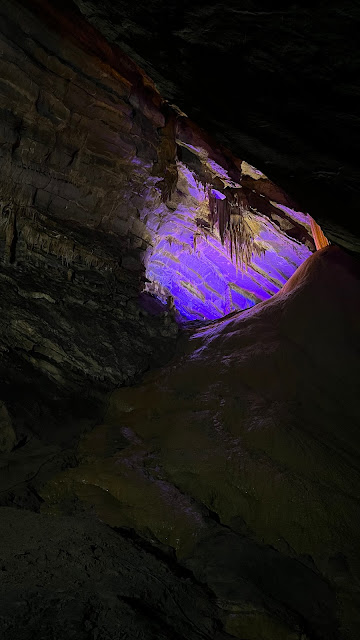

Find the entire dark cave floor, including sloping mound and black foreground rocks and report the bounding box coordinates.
[0,247,360,640]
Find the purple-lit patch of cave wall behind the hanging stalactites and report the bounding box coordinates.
[143,162,312,320]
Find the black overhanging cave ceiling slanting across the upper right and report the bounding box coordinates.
[71,0,360,251]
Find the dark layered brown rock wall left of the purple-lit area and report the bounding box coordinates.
[0,1,177,402]
